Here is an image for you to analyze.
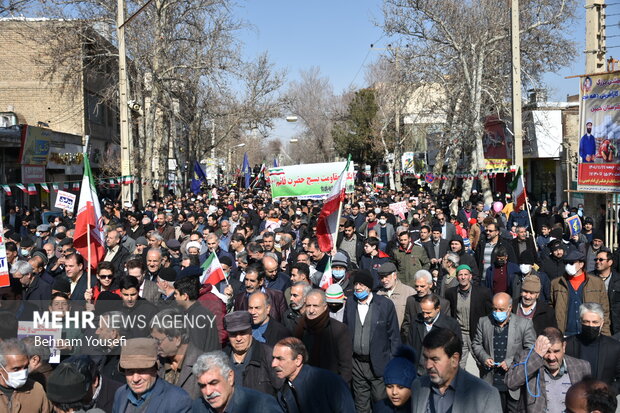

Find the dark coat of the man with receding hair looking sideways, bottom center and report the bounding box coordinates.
[278,364,355,413]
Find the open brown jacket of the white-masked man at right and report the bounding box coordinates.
[551,274,611,336]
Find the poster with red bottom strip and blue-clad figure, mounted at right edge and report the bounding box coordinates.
[577,72,620,192]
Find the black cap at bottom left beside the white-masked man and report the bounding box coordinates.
[47,363,90,403]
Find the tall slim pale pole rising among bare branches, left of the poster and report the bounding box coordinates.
[510,0,523,173]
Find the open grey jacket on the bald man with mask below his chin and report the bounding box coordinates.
[471,314,536,400]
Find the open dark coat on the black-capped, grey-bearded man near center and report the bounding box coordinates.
[342,294,400,377]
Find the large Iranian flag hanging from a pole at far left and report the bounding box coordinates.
[73,154,105,268]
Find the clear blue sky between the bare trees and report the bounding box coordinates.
[237,0,620,141]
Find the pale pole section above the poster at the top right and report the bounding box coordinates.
[585,0,607,74]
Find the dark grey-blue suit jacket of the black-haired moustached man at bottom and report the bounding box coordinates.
[411,368,502,413]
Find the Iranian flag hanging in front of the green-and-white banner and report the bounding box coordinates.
[316,157,351,252]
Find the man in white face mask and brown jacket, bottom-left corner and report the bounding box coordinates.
[0,339,51,413]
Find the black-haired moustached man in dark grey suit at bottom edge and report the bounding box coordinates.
[411,328,502,412]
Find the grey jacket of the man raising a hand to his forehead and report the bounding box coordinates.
[504,350,590,413]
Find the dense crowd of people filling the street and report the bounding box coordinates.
[0,186,620,413]
